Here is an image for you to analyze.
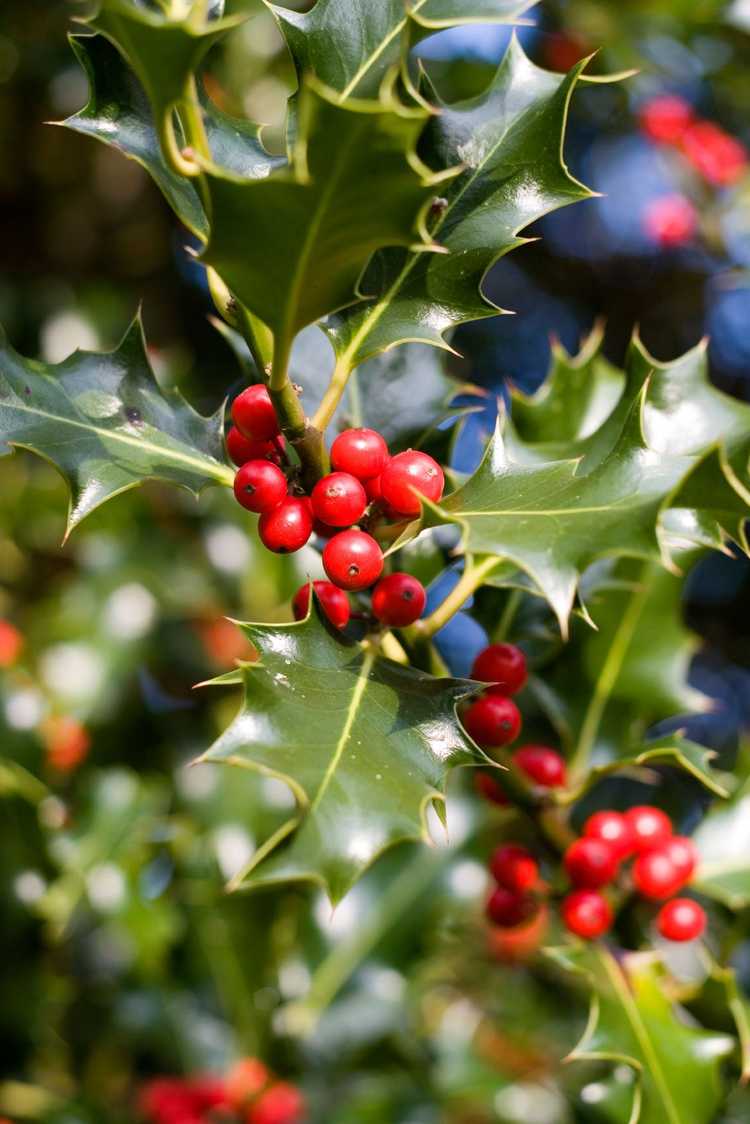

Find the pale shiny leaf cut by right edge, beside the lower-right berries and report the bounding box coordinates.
[693,751,750,909]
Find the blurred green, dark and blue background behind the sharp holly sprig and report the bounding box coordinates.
[0,0,750,1124]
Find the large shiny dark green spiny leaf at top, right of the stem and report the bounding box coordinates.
[327,38,591,368]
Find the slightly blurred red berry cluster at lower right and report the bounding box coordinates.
[487,804,706,941]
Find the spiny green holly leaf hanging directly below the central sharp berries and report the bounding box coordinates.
[200,606,487,901]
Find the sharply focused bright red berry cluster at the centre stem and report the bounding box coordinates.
[227,386,445,628]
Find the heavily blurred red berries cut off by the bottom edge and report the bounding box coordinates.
[139,1058,306,1124]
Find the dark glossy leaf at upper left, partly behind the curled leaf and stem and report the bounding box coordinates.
[62,35,283,238]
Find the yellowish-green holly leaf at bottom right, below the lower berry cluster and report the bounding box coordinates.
[552,945,734,1124]
